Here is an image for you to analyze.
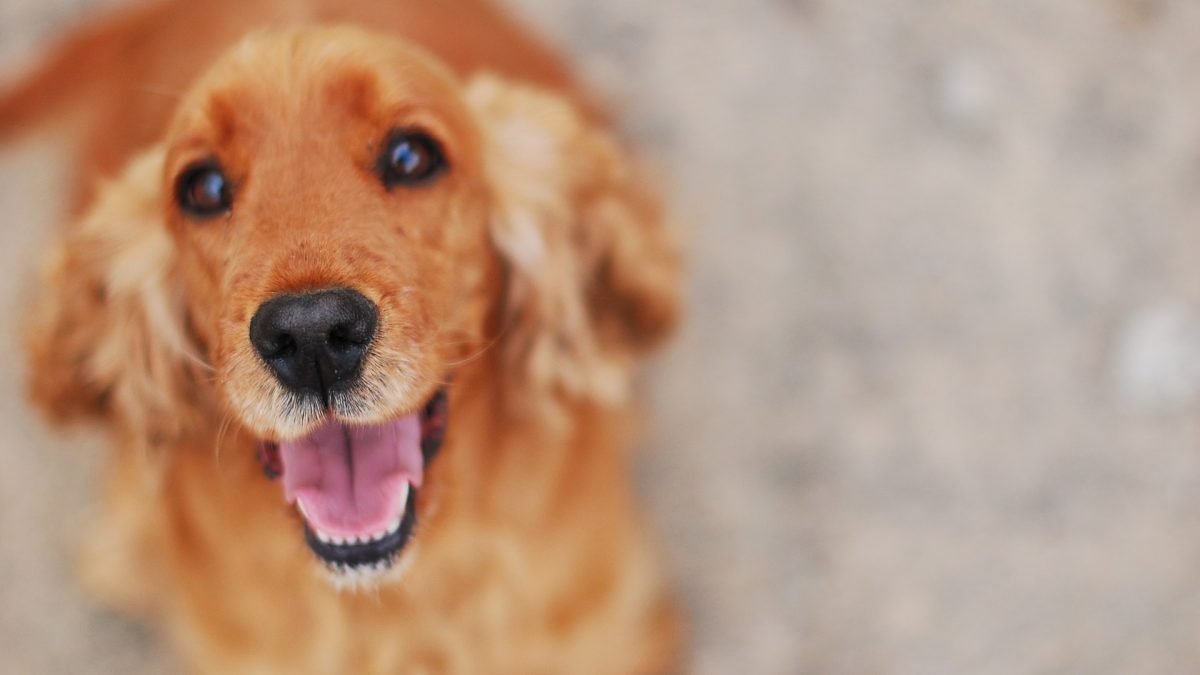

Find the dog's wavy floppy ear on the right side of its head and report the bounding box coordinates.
[467,76,679,402]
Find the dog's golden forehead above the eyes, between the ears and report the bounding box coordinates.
[172,29,467,144]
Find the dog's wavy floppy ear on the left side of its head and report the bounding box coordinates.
[26,144,203,446]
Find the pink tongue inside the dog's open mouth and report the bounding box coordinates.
[280,413,422,537]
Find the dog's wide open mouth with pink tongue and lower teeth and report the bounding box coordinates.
[256,390,446,573]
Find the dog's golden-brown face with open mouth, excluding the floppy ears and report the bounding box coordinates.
[162,34,496,569]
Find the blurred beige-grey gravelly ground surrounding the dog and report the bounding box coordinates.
[0,0,1200,675]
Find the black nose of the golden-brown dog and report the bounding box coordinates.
[243,288,378,399]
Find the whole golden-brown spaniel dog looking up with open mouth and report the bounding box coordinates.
[0,0,682,675]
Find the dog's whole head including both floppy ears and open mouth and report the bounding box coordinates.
[30,29,677,572]
